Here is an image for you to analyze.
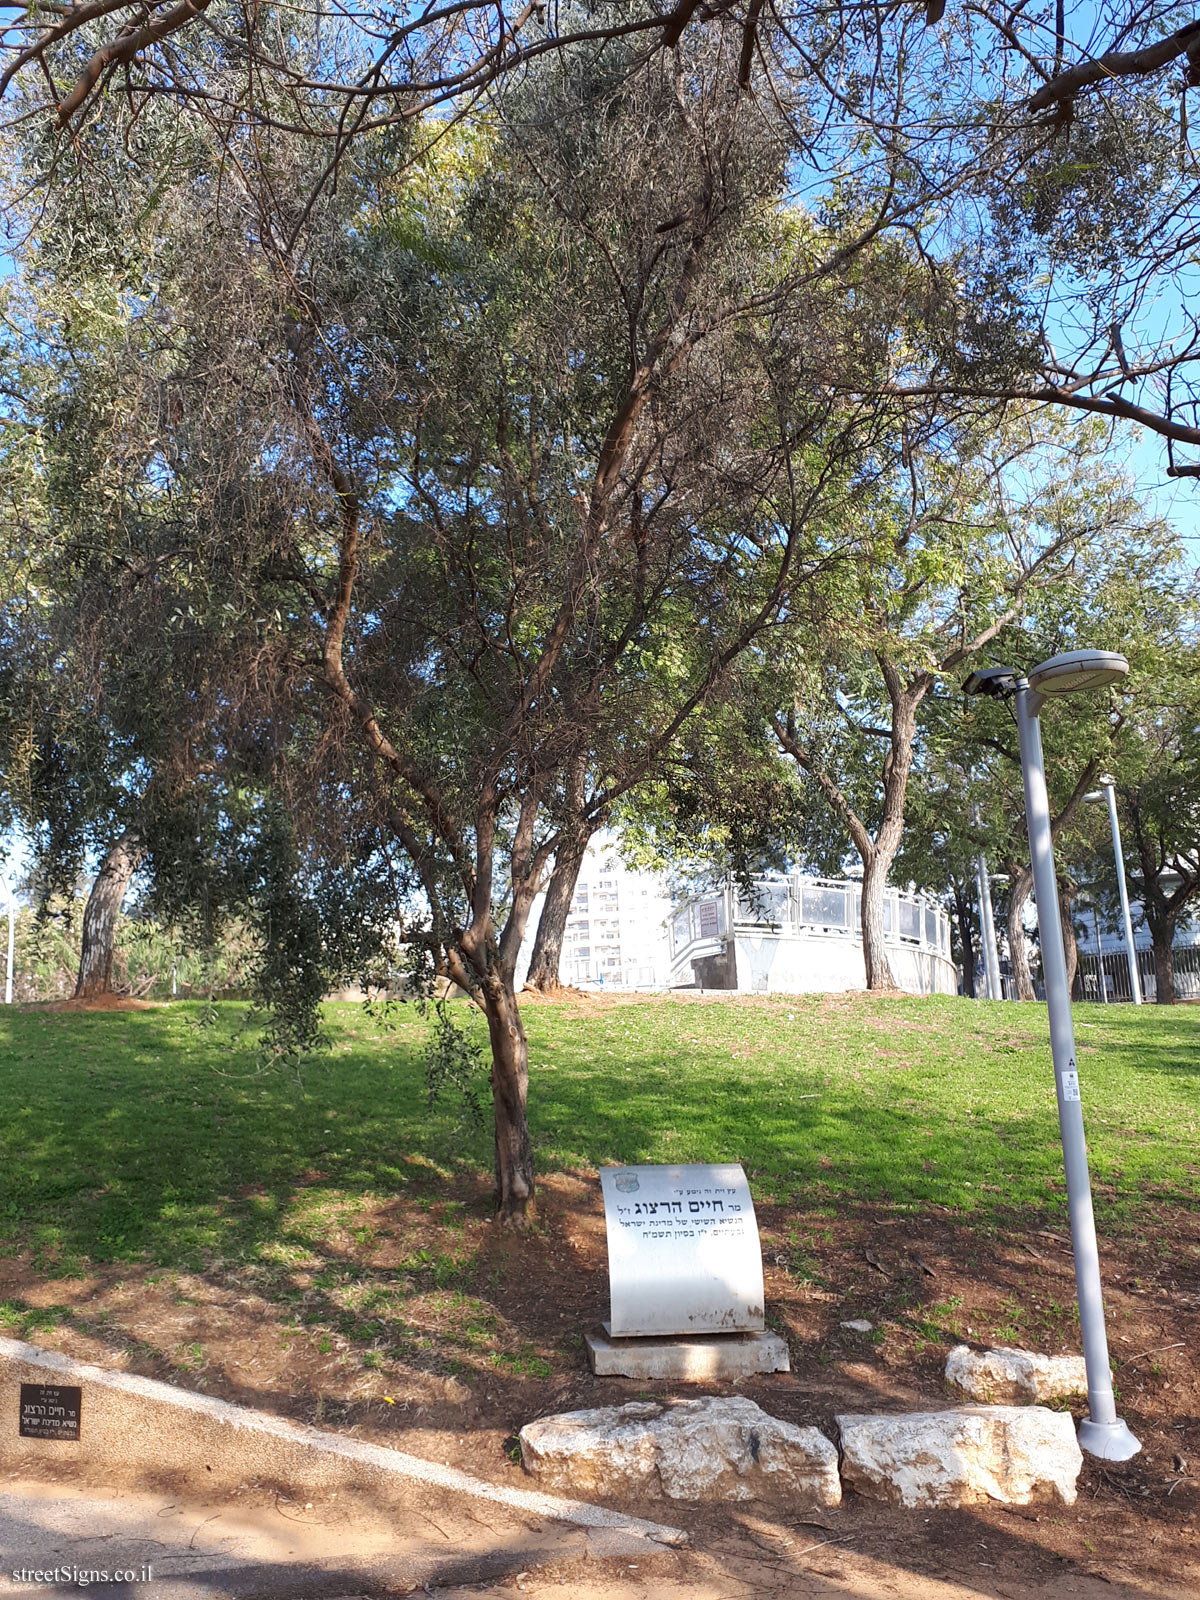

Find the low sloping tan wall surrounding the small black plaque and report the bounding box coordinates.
[0,1339,688,1546]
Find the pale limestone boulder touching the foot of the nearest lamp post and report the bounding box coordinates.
[837,1405,1083,1507]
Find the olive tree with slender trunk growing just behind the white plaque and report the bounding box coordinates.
[11,30,894,1221]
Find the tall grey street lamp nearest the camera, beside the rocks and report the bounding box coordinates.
[963,650,1141,1461]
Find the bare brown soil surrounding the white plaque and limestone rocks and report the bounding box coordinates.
[0,1173,1200,1600]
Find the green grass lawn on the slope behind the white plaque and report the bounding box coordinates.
[0,997,1200,1275]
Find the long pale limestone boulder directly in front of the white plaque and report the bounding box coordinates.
[520,1395,842,1506]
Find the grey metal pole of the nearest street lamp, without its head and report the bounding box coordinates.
[1016,678,1141,1461]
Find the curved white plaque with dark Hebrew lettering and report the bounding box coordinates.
[600,1163,763,1338]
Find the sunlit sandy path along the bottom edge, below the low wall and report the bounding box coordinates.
[0,1482,1177,1600]
